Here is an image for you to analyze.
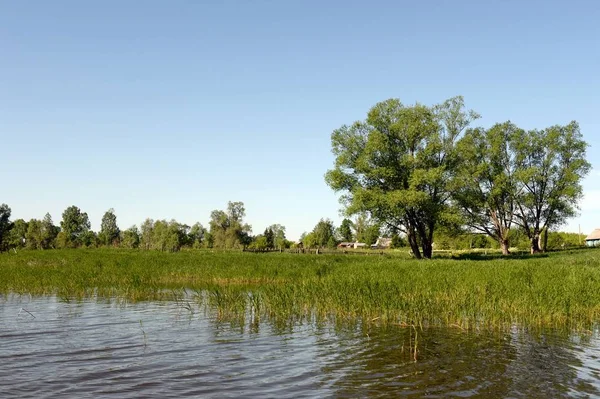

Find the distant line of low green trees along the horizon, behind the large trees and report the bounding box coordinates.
[0,202,582,252]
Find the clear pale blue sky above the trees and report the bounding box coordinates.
[0,0,600,239]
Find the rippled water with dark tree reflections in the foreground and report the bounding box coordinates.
[0,296,600,398]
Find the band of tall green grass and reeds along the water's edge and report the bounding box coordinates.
[0,249,600,330]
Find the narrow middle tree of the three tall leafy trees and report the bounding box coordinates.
[451,122,523,255]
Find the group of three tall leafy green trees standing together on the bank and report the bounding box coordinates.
[325,97,590,258]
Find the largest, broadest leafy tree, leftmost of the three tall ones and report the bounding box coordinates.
[326,97,478,258]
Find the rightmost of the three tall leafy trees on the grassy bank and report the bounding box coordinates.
[513,122,591,253]
